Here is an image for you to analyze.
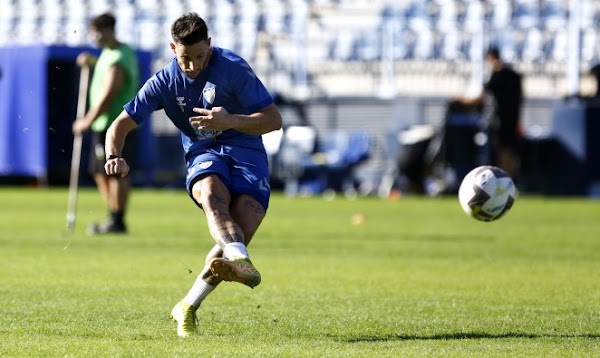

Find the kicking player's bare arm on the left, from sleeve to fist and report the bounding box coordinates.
[104,111,137,177]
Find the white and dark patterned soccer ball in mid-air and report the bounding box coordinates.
[458,165,518,221]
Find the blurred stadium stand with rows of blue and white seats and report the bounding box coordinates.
[0,0,600,97]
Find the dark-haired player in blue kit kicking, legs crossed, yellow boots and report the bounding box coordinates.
[105,13,282,337]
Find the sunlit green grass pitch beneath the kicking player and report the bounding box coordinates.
[0,188,600,357]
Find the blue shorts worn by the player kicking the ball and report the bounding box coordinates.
[185,145,271,211]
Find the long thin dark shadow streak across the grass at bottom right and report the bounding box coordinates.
[344,332,600,343]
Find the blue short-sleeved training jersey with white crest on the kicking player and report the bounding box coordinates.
[123,46,273,157]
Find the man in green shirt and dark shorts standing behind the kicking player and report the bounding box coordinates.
[73,13,140,235]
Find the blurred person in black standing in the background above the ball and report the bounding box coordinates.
[454,47,523,178]
